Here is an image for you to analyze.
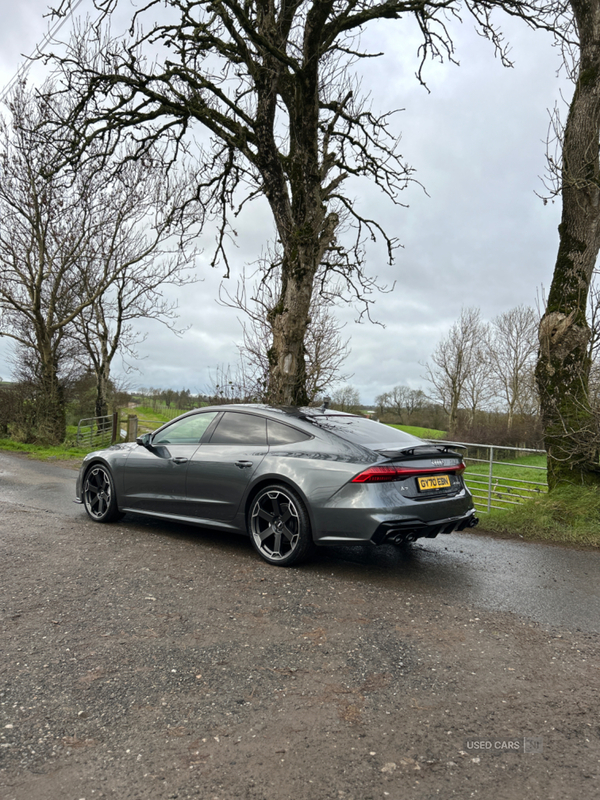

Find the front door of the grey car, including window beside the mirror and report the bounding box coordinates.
[123,411,219,516]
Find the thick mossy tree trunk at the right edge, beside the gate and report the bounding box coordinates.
[536,0,600,489]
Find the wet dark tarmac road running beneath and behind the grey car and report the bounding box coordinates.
[0,453,600,632]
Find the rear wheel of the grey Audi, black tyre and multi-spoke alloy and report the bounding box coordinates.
[247,484,314,567]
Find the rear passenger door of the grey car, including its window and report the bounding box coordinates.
[186,411,267,521]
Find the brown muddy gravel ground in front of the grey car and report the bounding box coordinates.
[0,460,600,800]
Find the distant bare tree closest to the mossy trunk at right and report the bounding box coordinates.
[487,305,538,430]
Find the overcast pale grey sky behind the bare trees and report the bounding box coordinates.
[0,0,571,403]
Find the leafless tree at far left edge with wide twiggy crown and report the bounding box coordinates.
[0,87,191,441]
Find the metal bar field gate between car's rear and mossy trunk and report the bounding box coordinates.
[431,439,548,513]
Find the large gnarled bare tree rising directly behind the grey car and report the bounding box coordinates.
[50,0,546,405]
